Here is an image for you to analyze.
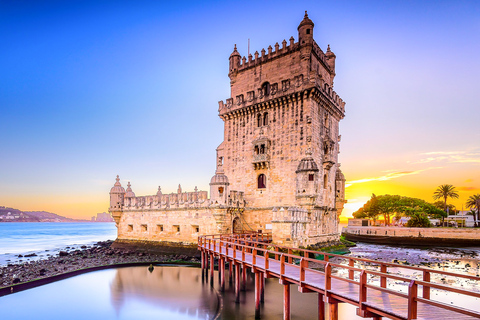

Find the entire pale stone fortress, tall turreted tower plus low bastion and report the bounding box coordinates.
[110,13,345,246]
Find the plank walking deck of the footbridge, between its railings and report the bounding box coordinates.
[199,241,479,320]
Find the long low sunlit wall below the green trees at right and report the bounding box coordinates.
[342,226,480,246]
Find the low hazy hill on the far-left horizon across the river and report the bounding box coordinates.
[0,206,89,222]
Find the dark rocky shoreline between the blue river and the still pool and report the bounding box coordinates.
[0,241,200,288]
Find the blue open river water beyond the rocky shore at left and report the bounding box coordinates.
[0,222,117,265]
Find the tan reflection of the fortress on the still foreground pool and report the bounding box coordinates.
[110,266,219,319]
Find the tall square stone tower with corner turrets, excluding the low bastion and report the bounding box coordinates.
[217,12,345,245]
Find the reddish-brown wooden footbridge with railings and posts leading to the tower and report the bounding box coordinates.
[198,233,480,320]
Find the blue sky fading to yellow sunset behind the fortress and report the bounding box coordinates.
[0,0,480,218]
